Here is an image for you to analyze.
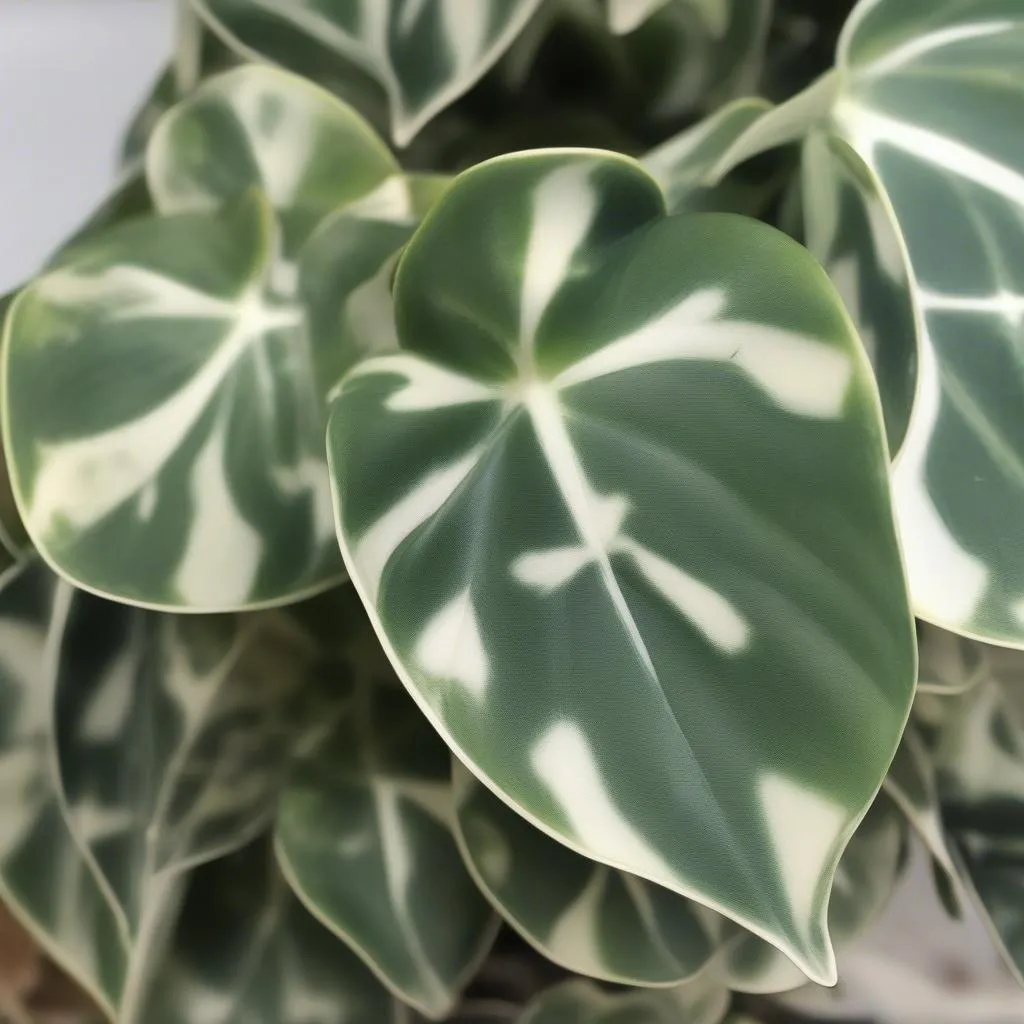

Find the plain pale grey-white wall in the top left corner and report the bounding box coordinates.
[0,0,174,293]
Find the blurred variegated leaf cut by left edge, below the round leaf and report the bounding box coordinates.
[0,559,128,1019]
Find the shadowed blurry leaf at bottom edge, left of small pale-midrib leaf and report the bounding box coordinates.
[145,841,414,1024]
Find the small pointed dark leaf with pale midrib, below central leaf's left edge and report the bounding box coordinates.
[275,593,498,1019]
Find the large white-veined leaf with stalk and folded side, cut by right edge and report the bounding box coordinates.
[704,0,1024,647]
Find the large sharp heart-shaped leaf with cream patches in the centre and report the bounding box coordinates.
[329,151,915,981]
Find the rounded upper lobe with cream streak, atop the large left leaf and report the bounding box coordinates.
[146,65,401,252]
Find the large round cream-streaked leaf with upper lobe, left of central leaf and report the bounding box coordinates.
[3,67,415,610]
